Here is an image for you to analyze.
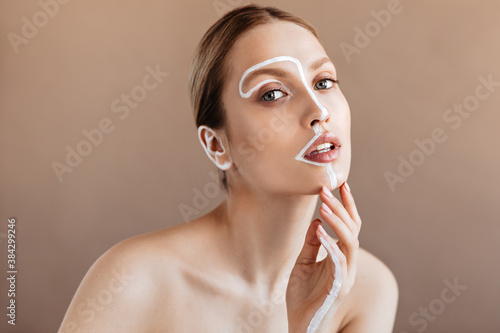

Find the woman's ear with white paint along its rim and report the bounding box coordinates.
[198,125,233,170]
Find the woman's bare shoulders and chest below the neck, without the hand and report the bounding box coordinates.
[59,211,398,333]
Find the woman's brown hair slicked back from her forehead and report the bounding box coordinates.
[189,5,319,189]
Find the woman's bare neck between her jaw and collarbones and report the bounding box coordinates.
[209,187,318,290]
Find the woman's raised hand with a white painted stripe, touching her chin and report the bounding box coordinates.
[286,183,361,333]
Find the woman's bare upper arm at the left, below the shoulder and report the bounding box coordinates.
[58,240,160,333]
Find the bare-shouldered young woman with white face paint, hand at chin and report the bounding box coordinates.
[59,5,398,333]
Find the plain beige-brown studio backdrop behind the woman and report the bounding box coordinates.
[0,0,500,333]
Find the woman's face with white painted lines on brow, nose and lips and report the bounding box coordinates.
[222,21,351,194]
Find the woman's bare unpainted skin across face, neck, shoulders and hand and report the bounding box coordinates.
[59,22,398,333]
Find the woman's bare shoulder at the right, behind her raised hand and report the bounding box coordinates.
[341,248,399,333]
